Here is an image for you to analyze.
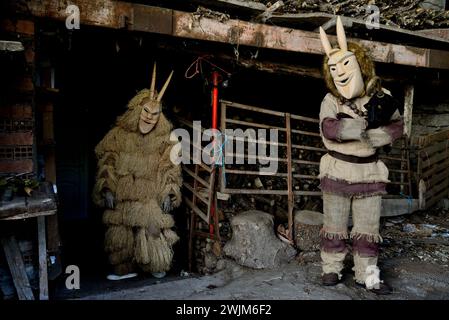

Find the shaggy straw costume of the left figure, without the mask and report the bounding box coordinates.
[93,84,182,275]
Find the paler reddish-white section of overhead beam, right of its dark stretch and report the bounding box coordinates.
[173,11,449,69]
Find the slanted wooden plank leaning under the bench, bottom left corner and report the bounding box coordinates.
[1,236,34,300]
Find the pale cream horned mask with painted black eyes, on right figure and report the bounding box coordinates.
[320,17,364,99]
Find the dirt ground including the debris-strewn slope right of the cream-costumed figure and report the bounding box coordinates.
[55,205,449,300]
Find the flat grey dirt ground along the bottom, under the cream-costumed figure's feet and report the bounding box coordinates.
[55,257,449,300]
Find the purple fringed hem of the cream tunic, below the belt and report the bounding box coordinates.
[320,177,387,196]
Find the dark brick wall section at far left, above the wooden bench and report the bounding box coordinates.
[0,18,35,174]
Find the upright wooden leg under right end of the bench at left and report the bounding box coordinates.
[37,216,48,300]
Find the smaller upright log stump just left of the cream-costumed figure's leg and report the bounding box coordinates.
[295,210,323,251]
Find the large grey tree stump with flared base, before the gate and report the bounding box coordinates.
[223,210,296,269]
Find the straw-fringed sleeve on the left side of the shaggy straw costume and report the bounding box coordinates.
[92,128,118,207]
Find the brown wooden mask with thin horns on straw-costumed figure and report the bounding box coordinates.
[139,62,173,134]
